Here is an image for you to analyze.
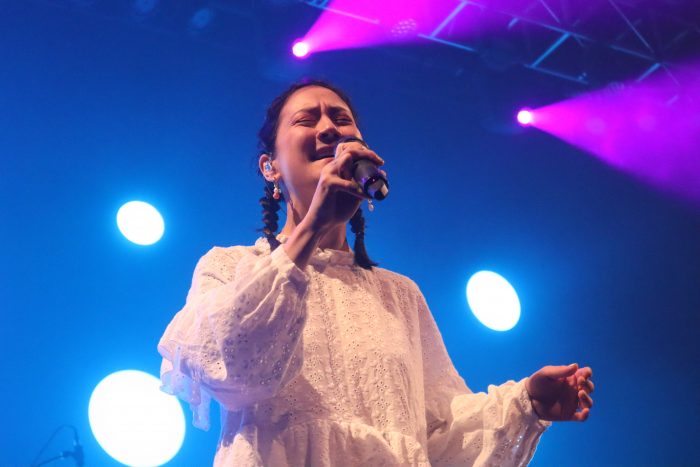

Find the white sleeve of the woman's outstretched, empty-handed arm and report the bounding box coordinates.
[416,288,551,466]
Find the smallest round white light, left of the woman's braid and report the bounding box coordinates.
[117,201,165,245]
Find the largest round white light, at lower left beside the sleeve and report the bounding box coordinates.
[88,370,185,467]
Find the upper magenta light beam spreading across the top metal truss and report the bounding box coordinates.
[303,0,640,53]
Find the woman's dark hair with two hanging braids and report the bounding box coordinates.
[255,80,378,270]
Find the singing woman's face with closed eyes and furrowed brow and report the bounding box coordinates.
[260,86,362,207]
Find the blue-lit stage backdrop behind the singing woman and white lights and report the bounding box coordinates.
[0,1,700,466]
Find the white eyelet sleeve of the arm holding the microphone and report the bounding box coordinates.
[158,246,309,430]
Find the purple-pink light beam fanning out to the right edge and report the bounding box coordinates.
[531,62,700,203]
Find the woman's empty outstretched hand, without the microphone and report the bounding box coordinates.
[525,363,594,422]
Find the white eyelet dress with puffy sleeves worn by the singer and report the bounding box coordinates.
[158,235,551,466]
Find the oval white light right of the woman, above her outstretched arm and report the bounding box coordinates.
[467,271,520,331]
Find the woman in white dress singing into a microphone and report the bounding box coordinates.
[158,81,593,467]
